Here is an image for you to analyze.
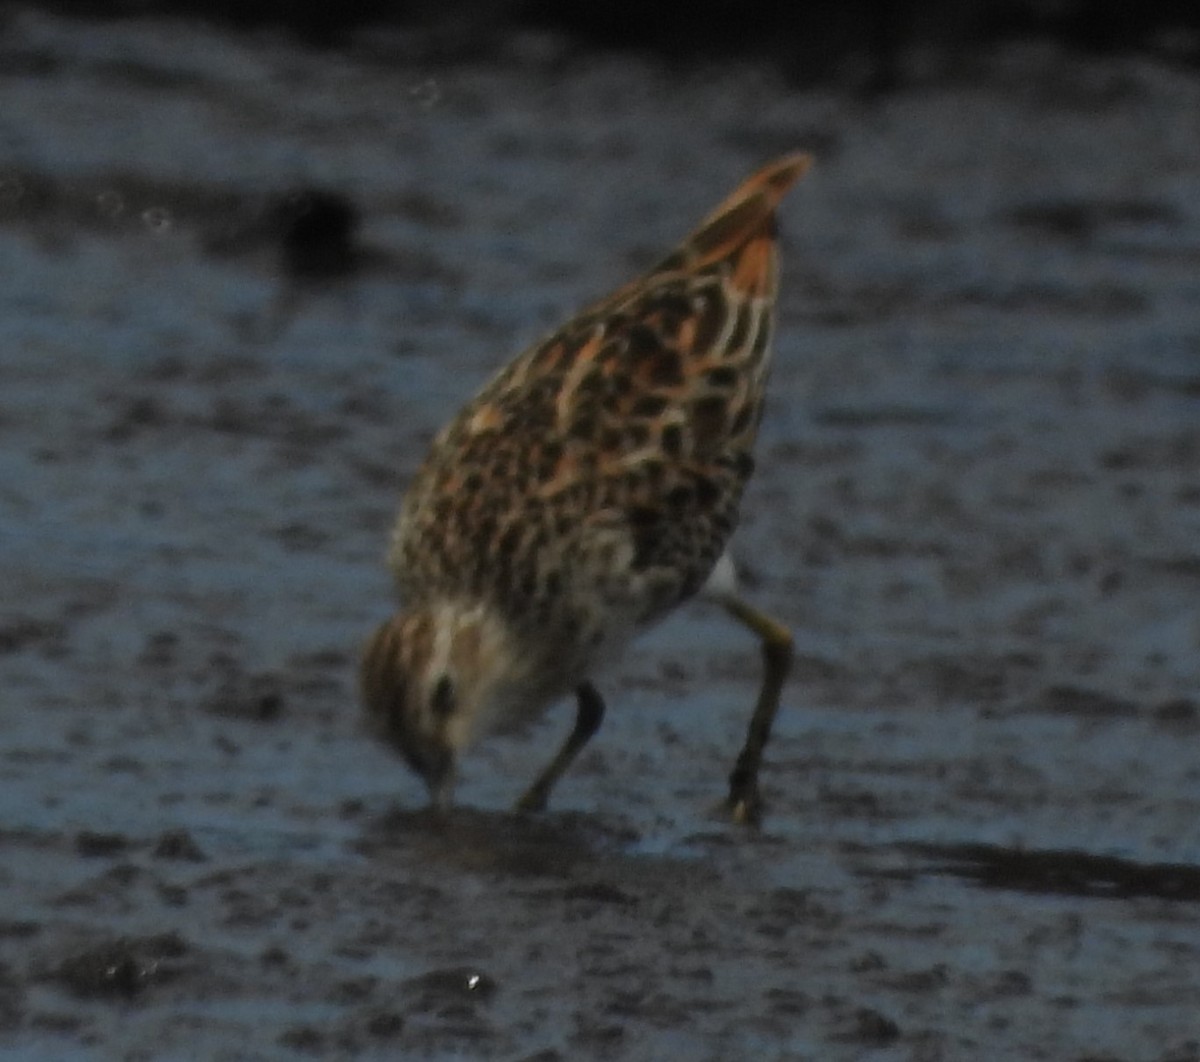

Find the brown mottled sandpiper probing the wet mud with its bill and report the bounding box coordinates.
[359,154,812,826]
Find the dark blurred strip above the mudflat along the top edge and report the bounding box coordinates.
[16,0,1200,82]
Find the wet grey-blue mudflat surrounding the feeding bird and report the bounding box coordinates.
[0,10,1200,1062]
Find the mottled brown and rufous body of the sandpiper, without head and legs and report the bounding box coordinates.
[390,156,809,653]
